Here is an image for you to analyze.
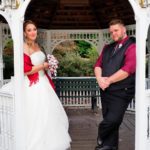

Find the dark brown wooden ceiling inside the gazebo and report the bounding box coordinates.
[1,0,135,29]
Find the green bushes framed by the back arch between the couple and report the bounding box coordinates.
[53,42,98,77]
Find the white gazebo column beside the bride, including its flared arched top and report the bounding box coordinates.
[0,0,30,150]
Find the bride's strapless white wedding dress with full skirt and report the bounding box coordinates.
[1,51,71,150]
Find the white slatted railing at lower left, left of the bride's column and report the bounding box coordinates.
[0,92,15,150]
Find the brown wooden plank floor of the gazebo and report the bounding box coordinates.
[66,109,135,150]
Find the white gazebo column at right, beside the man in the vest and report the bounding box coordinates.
[129,0,150,150]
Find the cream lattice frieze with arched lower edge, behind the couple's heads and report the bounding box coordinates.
[38,25,135,53]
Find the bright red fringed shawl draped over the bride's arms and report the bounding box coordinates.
[24,53,55,90]
